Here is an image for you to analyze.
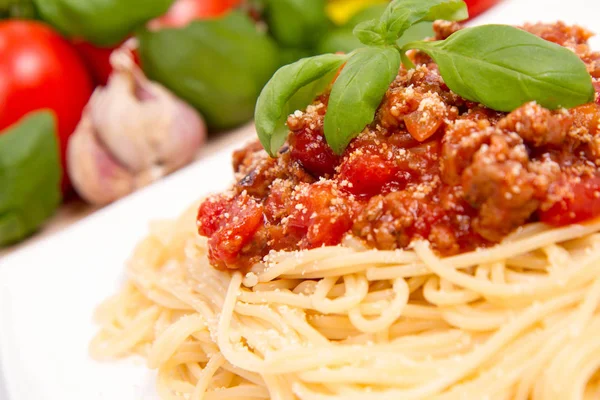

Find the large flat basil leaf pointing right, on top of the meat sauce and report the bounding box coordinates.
[404,25,594,112]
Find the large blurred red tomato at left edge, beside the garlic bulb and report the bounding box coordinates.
[0,20,92,191]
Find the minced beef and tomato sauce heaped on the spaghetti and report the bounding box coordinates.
[198,22,600,269]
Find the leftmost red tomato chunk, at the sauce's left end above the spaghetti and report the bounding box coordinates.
[208,195,263,268]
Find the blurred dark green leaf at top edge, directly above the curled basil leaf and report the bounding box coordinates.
[265,0,330,48]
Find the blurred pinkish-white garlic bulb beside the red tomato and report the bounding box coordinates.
[67,45,206,205]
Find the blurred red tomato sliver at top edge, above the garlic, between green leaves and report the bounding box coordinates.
[150,0,242,28]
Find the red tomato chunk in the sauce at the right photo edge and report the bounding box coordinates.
[540,176,600,226]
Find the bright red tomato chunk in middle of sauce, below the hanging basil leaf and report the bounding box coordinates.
[338,154,410,197]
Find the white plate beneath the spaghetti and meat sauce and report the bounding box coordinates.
[0,0,600,400]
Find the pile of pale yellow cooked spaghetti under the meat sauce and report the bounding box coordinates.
[91,207,600,400]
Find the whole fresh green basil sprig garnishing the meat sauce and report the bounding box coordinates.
[255,0,595,157]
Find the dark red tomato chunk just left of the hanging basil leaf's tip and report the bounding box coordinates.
[290,129,339,178]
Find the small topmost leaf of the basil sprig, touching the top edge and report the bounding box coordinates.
[381,0,469,44]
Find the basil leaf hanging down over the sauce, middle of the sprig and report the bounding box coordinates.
[324,47,400,154]
